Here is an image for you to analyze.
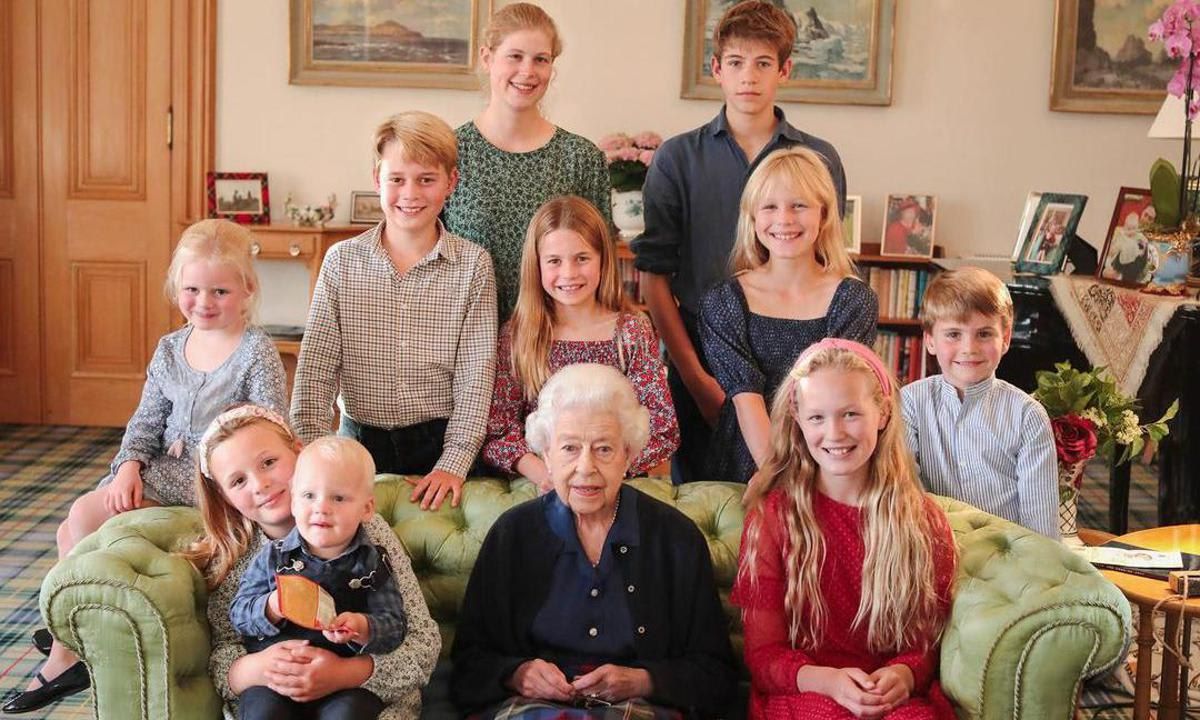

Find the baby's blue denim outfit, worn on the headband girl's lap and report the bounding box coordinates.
[229,526,408,656]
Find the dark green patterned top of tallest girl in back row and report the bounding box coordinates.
[443,122,612,324]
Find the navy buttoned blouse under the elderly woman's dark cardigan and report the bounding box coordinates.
[530,485,638,679]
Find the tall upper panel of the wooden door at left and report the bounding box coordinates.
[67,0,148,200]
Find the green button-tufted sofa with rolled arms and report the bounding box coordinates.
[41,475,1130,720]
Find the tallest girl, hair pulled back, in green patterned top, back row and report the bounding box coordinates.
[444,2,612,323]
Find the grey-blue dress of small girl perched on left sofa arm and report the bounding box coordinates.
[100,325,288,505]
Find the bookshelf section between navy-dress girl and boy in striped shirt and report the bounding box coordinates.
[852,242,941,384]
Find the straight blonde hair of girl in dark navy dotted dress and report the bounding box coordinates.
[730,146,854,277]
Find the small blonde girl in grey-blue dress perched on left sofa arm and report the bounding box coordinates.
[4,220,287,712]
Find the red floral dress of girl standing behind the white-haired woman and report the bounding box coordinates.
[481,312,679,475]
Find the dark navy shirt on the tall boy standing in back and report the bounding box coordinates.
[630,107,846,316]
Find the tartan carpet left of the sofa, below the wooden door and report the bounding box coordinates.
[0,425,124,719]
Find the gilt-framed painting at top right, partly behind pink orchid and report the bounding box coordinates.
[1050,0,1178,115]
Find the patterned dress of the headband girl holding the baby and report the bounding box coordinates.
[208,515,442,720]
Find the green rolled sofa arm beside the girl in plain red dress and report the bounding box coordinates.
[941,503,1132,720]
